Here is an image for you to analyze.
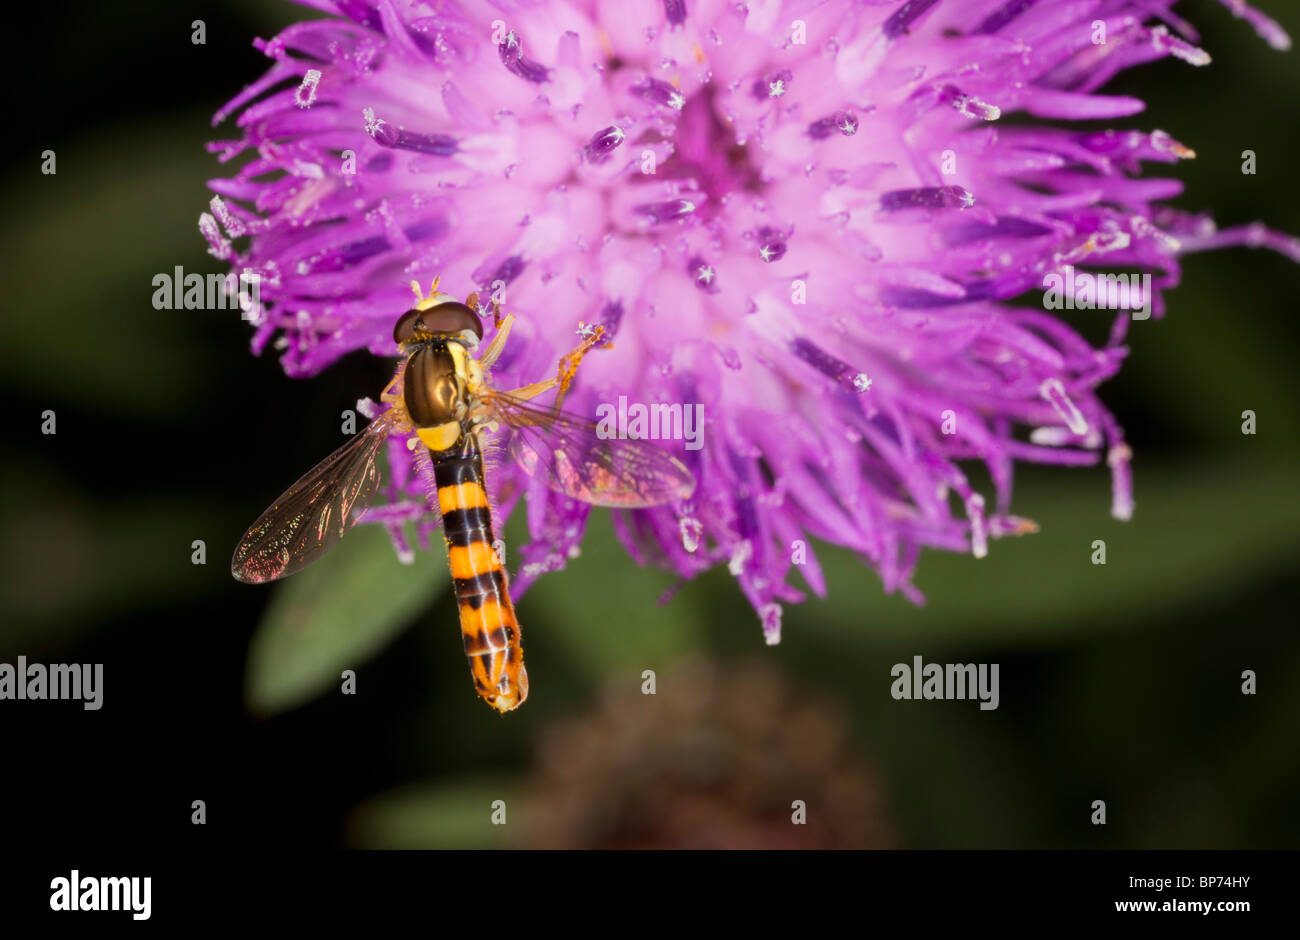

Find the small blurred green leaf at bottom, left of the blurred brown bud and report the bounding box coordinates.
[348,779,517,849]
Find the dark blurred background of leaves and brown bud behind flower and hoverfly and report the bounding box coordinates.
[0,0,1300,849]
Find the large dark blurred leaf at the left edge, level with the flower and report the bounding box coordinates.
[0,112,223,417]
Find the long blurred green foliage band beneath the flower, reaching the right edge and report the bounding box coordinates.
[501,457,1300,675]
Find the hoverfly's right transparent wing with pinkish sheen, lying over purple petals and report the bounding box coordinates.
[482,391,696,510]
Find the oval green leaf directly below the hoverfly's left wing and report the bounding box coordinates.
[246,525,447,714]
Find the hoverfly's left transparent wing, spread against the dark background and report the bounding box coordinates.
[230,412,393,584]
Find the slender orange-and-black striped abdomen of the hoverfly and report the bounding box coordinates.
[433,454,528,711]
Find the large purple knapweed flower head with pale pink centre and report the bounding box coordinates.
[200,0,1300,642]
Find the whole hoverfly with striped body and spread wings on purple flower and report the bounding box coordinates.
[230,280,696,712]
